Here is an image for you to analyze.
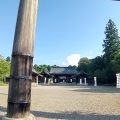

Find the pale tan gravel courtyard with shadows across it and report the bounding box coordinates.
[0,86,120,120]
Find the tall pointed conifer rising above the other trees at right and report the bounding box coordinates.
[103,19,120,66]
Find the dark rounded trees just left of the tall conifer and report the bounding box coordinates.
[77,56,106,81]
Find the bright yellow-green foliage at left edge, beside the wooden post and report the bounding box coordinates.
[0,55,10,79]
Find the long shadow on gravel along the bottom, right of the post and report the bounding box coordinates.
[32,111,120,120]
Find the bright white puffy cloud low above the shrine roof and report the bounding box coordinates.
[62,54,80,66]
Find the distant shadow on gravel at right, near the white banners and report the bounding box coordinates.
[64,86,120,94]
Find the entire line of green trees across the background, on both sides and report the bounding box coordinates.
[0,19,120,83]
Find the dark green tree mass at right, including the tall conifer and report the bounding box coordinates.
[77,19,120,83]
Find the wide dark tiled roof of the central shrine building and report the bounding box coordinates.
[50,67,77,75]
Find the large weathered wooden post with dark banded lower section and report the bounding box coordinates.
[7,0,38,118]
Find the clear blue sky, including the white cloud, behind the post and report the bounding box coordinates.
[0,0,120,66]
